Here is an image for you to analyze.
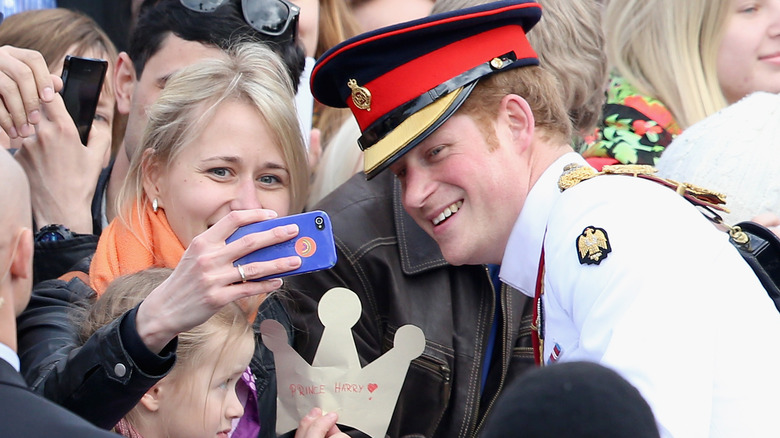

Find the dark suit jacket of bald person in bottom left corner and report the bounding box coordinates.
[0,359,116,438]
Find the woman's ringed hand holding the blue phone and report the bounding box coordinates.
[136,209,301,353]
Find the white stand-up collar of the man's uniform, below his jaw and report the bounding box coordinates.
[499,152,587,296]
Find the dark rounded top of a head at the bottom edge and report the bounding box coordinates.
[480,362,659,438]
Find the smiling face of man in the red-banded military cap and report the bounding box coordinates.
[390,114,530,265]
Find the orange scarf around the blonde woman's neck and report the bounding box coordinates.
[89,203,184,296]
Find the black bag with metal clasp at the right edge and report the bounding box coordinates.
[729,221,780,310]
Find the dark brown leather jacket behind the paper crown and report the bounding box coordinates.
[285,172,533,438]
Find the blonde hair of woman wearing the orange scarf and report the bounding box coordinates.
[117,42,309,233]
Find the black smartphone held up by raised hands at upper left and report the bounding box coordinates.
[60,55,108,145]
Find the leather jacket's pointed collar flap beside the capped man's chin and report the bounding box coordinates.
[393,178,448,275]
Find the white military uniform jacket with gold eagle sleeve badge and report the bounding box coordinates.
[501,153,780,437]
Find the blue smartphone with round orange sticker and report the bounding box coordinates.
[225,210,337,281]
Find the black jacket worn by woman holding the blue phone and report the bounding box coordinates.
[17,253,292,438]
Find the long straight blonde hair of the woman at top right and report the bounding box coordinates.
[604,0,730,129]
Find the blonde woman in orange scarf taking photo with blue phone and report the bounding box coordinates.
[19,39,308,428]
